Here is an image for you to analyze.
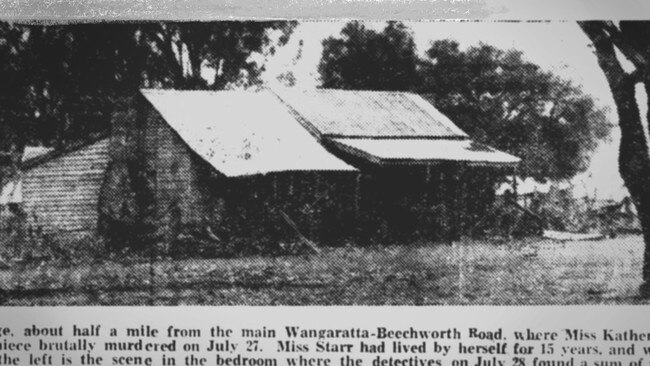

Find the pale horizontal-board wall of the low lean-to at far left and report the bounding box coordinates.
[22,139,108,232]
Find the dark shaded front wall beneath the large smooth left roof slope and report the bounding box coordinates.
[225,171,358,246]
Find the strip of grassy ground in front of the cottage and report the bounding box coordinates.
[0,236,644,305]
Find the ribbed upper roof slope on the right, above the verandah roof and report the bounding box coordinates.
[275,89,468,138]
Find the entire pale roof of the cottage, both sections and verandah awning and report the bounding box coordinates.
[141,89,519,177]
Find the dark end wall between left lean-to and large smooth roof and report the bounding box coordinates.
[100,95,215,250]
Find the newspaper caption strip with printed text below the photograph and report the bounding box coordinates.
[0,306,650,366]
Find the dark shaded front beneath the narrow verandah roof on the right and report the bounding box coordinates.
[360,163,498,242]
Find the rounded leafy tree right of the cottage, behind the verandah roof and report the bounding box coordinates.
[416,40,610,181]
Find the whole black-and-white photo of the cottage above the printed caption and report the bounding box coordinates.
[0,9,650,306]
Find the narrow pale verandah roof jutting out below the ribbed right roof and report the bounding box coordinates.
[332,138,520,166]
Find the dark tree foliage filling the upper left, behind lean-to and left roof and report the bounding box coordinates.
[0,21,295,147]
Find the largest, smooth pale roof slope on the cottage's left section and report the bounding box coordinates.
[142,90,356,177]
